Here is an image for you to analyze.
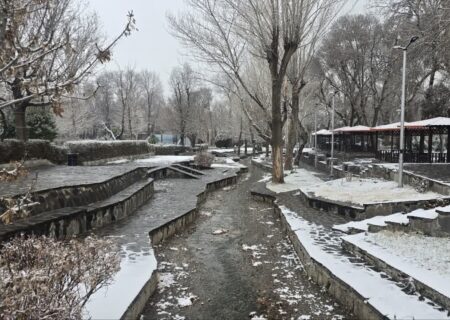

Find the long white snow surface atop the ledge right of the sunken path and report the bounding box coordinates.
[279,206,450,319]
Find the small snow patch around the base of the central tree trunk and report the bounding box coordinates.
[266,169,323,193]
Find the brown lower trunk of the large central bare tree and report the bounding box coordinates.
[271,79,284,183]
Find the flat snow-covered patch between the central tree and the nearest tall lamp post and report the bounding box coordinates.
[301,178,442,204]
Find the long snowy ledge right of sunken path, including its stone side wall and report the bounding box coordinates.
[278,205,450,319]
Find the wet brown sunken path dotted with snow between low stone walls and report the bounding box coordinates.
[143,162,352,320]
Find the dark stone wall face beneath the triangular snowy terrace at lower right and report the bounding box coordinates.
[342,239,450,310]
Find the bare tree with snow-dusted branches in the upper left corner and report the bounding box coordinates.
[0,0,134,140]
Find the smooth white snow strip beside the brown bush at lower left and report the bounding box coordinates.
[85,247,157,319]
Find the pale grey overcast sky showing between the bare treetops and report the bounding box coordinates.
[88,0,368,93]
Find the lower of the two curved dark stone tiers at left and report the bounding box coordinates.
[0,179,154,241]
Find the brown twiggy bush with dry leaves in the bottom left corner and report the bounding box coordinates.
[0,236,120,319]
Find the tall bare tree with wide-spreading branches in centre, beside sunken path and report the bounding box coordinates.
[169,0,344,183]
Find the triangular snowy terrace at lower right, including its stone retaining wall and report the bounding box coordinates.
[342,231,450,310]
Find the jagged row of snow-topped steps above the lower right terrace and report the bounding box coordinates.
[333,206,450,233]
